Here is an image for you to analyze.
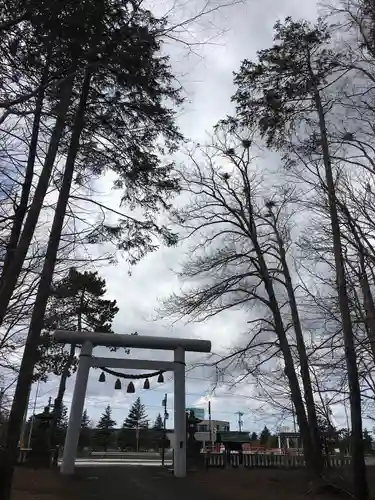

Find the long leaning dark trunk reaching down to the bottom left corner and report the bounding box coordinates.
[0,70,90,500]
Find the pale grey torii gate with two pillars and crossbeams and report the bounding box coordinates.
[54,330,211,477]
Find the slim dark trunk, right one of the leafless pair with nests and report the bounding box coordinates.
[274,221,324,472]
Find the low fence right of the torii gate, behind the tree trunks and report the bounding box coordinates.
[205,453,350,469]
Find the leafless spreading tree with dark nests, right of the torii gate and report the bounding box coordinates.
[166,124,323,473]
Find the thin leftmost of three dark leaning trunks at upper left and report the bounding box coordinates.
[0,56,49,289]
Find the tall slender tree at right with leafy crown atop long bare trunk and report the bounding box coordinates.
[234,18,368,499]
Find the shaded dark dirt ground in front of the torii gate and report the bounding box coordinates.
[12,467,375,500]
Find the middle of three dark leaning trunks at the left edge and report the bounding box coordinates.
[0,65,74,326]
